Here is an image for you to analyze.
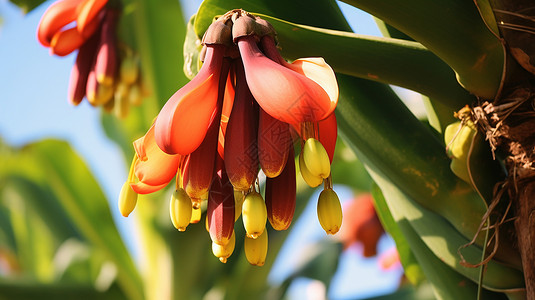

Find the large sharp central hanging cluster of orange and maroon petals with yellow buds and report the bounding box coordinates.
[119,10,342,266]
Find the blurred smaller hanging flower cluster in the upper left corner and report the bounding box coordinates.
[37,0,145,118]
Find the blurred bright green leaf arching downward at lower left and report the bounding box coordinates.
[0,140,142,299]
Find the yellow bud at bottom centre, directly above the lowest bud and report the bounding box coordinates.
[242,192,267,239]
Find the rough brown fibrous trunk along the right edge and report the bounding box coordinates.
[484,0,535,299]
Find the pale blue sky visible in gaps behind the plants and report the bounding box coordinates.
[0,0,399,298]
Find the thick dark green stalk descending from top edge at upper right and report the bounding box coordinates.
[344,0,505,99]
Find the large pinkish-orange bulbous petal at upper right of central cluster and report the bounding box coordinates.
[238,36,333,124]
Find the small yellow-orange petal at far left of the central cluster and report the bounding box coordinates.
[134,126,180,188]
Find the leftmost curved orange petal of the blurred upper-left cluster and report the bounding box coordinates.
[37,0,82,47]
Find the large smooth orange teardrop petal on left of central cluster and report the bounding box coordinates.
[154,45,226,155]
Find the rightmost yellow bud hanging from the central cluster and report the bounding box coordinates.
[318,189,342,234]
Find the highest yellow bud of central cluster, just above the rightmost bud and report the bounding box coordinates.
[302,138,331,178]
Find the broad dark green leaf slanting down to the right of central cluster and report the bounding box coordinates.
[337,74,517,264]
